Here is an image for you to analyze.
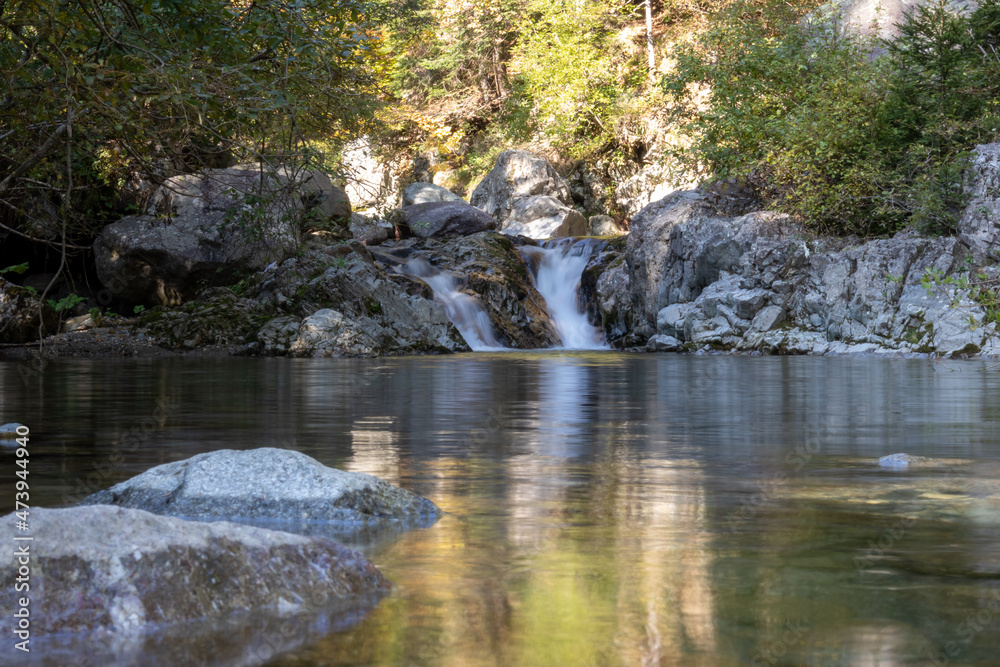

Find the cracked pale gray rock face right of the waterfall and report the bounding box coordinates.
[596,144,1000,355]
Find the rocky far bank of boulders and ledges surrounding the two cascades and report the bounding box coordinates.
[0,144,1000,358]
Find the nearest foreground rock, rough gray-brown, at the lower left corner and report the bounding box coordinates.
[0,506,388,636]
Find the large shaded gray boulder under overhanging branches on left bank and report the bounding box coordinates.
[94,165,350,305]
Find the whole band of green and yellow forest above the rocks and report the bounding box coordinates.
[0,0,1000,248]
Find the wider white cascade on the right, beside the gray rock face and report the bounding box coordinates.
[520,238,608,350]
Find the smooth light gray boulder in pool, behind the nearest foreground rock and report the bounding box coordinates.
[81,447,441,522]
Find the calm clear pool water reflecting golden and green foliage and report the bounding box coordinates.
[0,352,1000,667]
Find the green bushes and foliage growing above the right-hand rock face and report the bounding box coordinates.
[664,0,1000,236]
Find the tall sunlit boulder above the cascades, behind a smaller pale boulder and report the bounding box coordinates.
[469,150,573,225]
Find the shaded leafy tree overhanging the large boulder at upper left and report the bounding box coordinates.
[0,0,379,248]
